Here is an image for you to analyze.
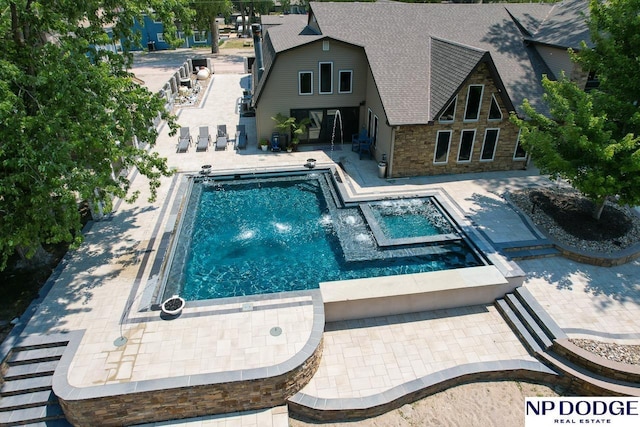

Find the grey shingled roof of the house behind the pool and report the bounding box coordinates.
[257,0,592,126]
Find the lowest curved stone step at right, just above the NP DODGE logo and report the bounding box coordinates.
[539,352,640,396]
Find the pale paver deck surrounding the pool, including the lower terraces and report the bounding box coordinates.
[5,49,640,426]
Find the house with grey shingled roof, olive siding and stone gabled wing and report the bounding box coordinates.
[252,0,588,178]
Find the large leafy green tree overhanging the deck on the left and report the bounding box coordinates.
[0,0,189,269]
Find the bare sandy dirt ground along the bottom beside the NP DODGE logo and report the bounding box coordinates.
[289,381,558,427]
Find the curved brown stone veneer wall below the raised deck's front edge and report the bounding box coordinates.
[60,340,323,426]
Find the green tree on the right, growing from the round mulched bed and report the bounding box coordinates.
[512,0,640,219]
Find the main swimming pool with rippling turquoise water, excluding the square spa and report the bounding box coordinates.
[164,173,482,300]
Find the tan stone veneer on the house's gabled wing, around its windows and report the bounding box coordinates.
[390,64,525,178]
